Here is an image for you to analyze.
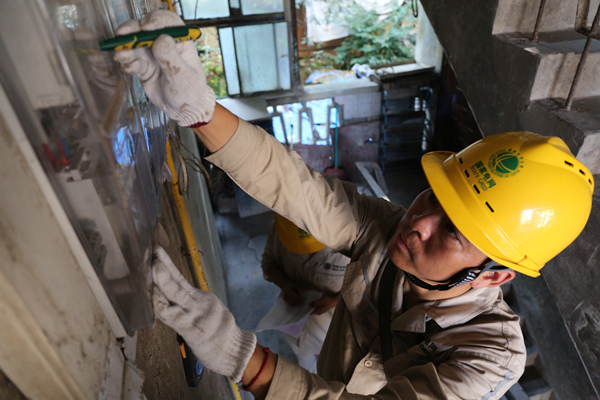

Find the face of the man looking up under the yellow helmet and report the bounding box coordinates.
[388,189,487,283]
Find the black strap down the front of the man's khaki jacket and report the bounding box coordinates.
[377,261,398,362]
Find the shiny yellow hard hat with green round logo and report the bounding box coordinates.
[421,132,594,277]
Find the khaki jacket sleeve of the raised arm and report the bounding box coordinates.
[207,120,366,253]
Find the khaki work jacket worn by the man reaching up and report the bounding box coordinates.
[207,120,526,400]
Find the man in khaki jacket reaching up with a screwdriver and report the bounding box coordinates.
[115,11,593,400]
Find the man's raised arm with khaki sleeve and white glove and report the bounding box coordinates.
[115,10,370,250]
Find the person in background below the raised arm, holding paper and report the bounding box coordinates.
[261,214,350,372]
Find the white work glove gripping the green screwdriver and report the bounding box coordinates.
[115,10,215,126]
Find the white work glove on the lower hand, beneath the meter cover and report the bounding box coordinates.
[152,246,256,382]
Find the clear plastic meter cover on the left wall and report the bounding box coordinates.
[0,0,166,334]
